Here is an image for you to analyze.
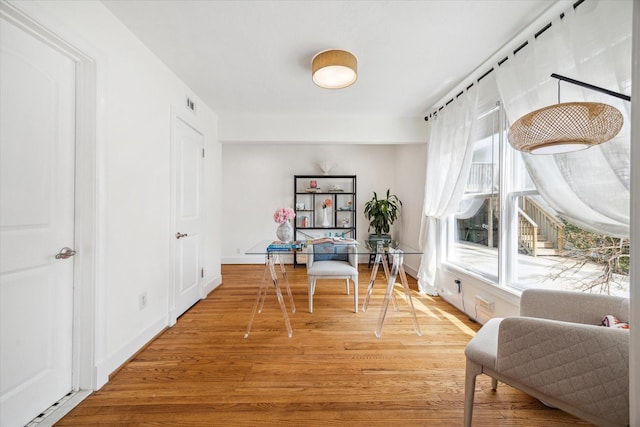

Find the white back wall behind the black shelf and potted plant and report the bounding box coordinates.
[222,143,424,264]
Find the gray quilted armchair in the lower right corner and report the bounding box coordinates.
[464,289,633,427]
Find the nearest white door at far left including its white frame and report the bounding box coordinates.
[0,2,97,426]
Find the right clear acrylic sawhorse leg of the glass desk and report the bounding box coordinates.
[362,249,422,338]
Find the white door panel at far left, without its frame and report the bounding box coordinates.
[0,15,75,427]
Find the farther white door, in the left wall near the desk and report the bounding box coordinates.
[171,117,204,322]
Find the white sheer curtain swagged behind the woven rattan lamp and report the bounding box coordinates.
[495,0,632,237]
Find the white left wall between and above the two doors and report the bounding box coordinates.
[14,1,221,387]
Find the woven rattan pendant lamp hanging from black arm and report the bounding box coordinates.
[507,74,631,154]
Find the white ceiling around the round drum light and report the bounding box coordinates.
[102,0,554,123]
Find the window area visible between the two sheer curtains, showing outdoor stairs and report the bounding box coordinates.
[446,99,629,295]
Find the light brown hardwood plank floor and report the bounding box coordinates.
[56,265,589,426]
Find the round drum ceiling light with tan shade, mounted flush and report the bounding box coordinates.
[311,49,358,89]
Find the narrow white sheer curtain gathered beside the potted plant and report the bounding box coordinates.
[418,85,478,295]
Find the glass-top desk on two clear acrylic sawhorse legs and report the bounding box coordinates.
[244,237,422,338]
